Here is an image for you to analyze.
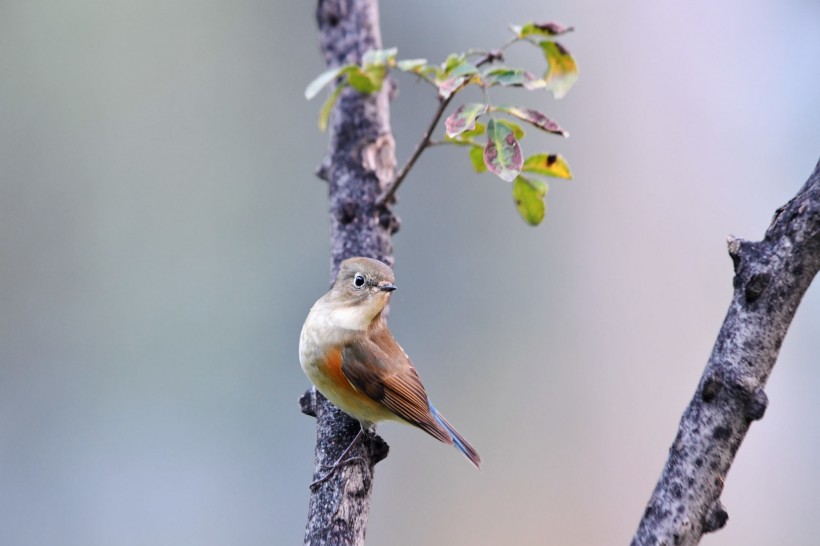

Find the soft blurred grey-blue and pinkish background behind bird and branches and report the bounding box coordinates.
[0,0,820,546]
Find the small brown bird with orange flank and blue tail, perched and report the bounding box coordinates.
[299,258,481,468]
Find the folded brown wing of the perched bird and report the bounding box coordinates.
[342,328,453,444]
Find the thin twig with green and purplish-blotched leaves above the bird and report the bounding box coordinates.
[305,22,578,225]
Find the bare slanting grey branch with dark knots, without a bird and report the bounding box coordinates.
[632,155,820,546]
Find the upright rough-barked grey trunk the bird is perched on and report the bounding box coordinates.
[300,0,398,546]
